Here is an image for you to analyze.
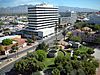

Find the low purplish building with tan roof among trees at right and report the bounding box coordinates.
[72,27,100,42]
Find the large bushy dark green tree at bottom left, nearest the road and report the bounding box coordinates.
[14,58,45,75]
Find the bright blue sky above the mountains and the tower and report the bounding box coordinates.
[0,0,100,10]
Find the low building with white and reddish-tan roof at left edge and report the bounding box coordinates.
[0,35,27,54]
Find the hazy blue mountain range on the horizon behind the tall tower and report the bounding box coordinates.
[0,5,98,14]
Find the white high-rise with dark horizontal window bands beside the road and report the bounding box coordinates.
[24,4,58,39]
